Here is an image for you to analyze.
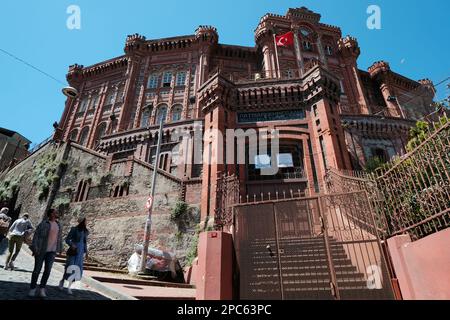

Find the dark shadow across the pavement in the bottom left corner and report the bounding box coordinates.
[0,280,110,300]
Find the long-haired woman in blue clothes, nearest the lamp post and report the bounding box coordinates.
[59,216,89,294]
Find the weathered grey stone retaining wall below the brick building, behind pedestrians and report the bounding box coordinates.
[0,143,200,267]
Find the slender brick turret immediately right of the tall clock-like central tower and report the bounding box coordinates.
[338,36,369,114]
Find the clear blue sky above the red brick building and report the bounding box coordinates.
[0,0,450,143]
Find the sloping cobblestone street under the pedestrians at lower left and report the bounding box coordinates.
[0,239,109,300]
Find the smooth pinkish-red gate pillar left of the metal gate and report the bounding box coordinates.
[196,231,233,300]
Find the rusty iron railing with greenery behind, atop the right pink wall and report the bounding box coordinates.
[325,122,450,240]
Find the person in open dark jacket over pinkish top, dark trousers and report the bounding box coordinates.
[28,209,63,298]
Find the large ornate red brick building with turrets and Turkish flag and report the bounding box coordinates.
[58,8,434,222]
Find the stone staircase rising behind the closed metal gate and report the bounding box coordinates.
[241,237,391,300]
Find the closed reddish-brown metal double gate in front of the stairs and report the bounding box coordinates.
[234,191,393,299]
